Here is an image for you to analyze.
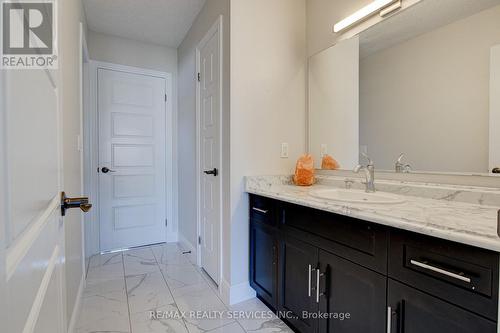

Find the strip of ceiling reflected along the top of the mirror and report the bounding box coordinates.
[359,0,500,58]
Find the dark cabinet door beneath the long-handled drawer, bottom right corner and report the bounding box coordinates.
[388,279,497,333]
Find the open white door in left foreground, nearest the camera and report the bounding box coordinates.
[0,63,67,333]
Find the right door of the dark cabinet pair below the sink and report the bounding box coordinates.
[319,250,387,333]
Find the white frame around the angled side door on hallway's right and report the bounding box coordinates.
[196,15,225,290]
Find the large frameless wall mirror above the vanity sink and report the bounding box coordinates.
[308,0,500,173]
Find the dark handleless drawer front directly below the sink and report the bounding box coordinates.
[279,203,388,274]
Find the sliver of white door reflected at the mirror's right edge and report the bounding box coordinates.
[489,45,500,172]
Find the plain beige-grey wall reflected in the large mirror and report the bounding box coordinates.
[360,6,500,172]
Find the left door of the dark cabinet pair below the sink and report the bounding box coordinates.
[279,236,318,333]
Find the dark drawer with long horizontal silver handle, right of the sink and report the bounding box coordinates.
[389,231,499,321]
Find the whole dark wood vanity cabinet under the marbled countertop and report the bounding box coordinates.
[250,195,499,333]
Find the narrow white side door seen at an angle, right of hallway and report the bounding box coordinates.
[198,23,221,283]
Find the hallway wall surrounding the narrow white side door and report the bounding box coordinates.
[177,0,230,251]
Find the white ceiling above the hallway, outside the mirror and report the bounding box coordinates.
[83,0,205,48]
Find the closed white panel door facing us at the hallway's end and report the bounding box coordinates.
[98,69,166,251]
